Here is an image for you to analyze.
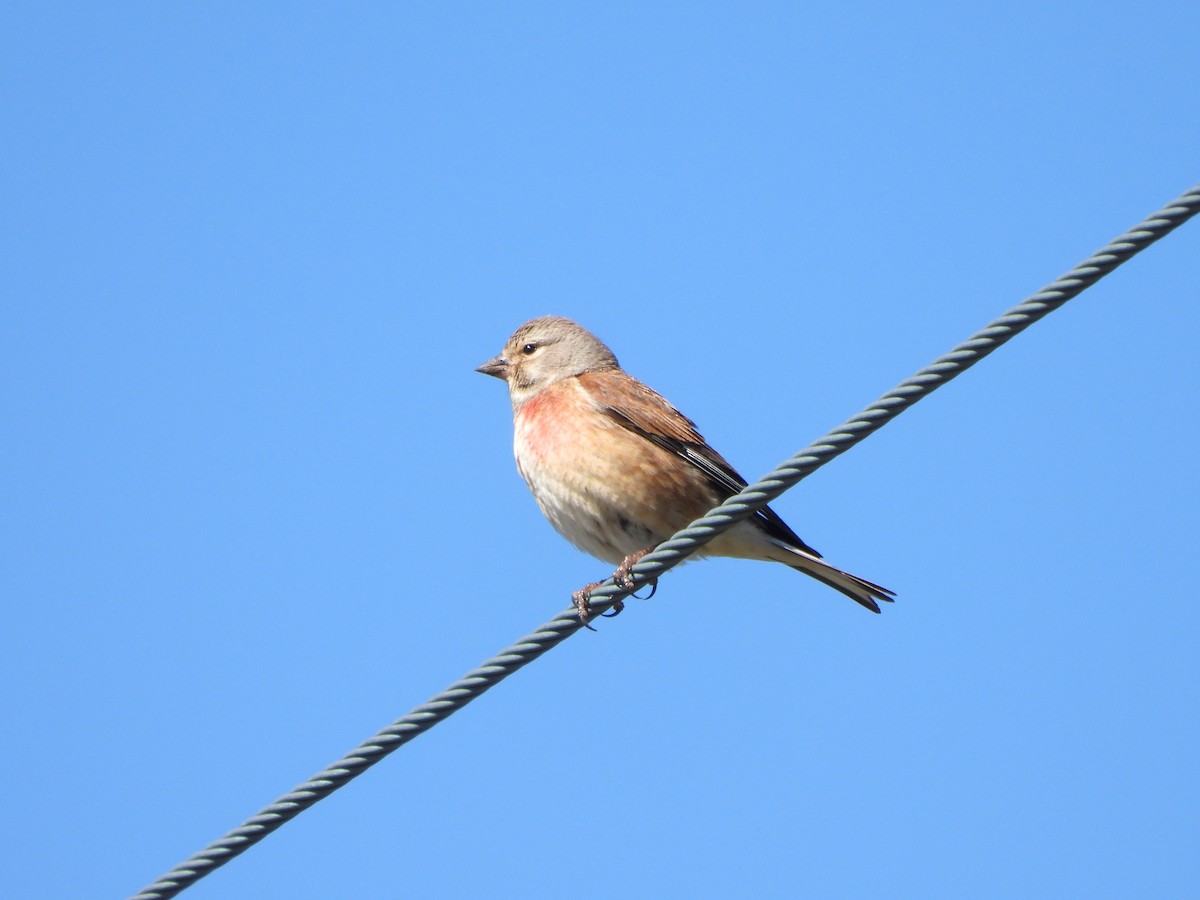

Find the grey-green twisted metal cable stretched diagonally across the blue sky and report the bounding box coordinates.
[134,185,1200,900]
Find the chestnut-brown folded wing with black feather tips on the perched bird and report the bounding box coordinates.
[578,371,821,559]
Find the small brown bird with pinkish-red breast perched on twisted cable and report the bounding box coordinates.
[475,316,894,624]
